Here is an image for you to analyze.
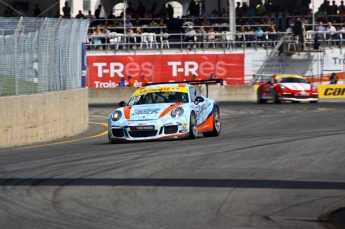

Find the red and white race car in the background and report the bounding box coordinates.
[257,74,319,103]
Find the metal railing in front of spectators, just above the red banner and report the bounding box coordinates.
[86,31,345,55]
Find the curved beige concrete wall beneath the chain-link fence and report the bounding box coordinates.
[0,88,89,148]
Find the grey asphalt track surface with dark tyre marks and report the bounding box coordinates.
[0,102,345,229]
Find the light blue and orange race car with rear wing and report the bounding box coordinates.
[108,79,223,143]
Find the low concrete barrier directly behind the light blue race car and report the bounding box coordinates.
[89,86,256,104]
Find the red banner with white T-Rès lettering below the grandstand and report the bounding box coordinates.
[87,54,244,88]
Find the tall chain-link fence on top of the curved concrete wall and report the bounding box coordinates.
[0,18,89,96]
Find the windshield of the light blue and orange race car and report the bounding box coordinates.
[127,92,189,106]
